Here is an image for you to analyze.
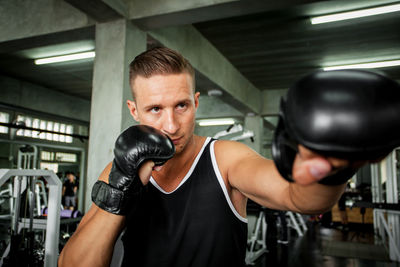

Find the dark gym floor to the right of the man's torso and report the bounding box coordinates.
[249,224,400,267]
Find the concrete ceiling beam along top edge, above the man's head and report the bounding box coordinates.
[127,0,320,30]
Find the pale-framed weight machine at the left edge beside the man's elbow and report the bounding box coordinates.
[0,145,62,267]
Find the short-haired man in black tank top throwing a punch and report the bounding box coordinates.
[59,48,376,266]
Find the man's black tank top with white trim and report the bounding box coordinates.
[122,138,247,267]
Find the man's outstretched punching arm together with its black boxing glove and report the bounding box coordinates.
[224,70,400,213]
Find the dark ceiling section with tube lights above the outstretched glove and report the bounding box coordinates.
[195,4,400,90]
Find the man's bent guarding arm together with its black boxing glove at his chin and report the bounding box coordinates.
[59,125,175,266]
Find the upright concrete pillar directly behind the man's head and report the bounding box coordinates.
[84,19,146,211]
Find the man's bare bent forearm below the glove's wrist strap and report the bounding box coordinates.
[58,164,125,267]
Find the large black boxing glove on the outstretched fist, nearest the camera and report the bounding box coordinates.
[272,70,400,185]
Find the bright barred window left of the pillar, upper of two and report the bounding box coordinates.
[17,115,74,143]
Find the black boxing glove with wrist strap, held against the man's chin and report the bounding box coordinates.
[92,125,175,215]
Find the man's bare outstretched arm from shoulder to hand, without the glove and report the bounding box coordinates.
[216,141,344,214]
